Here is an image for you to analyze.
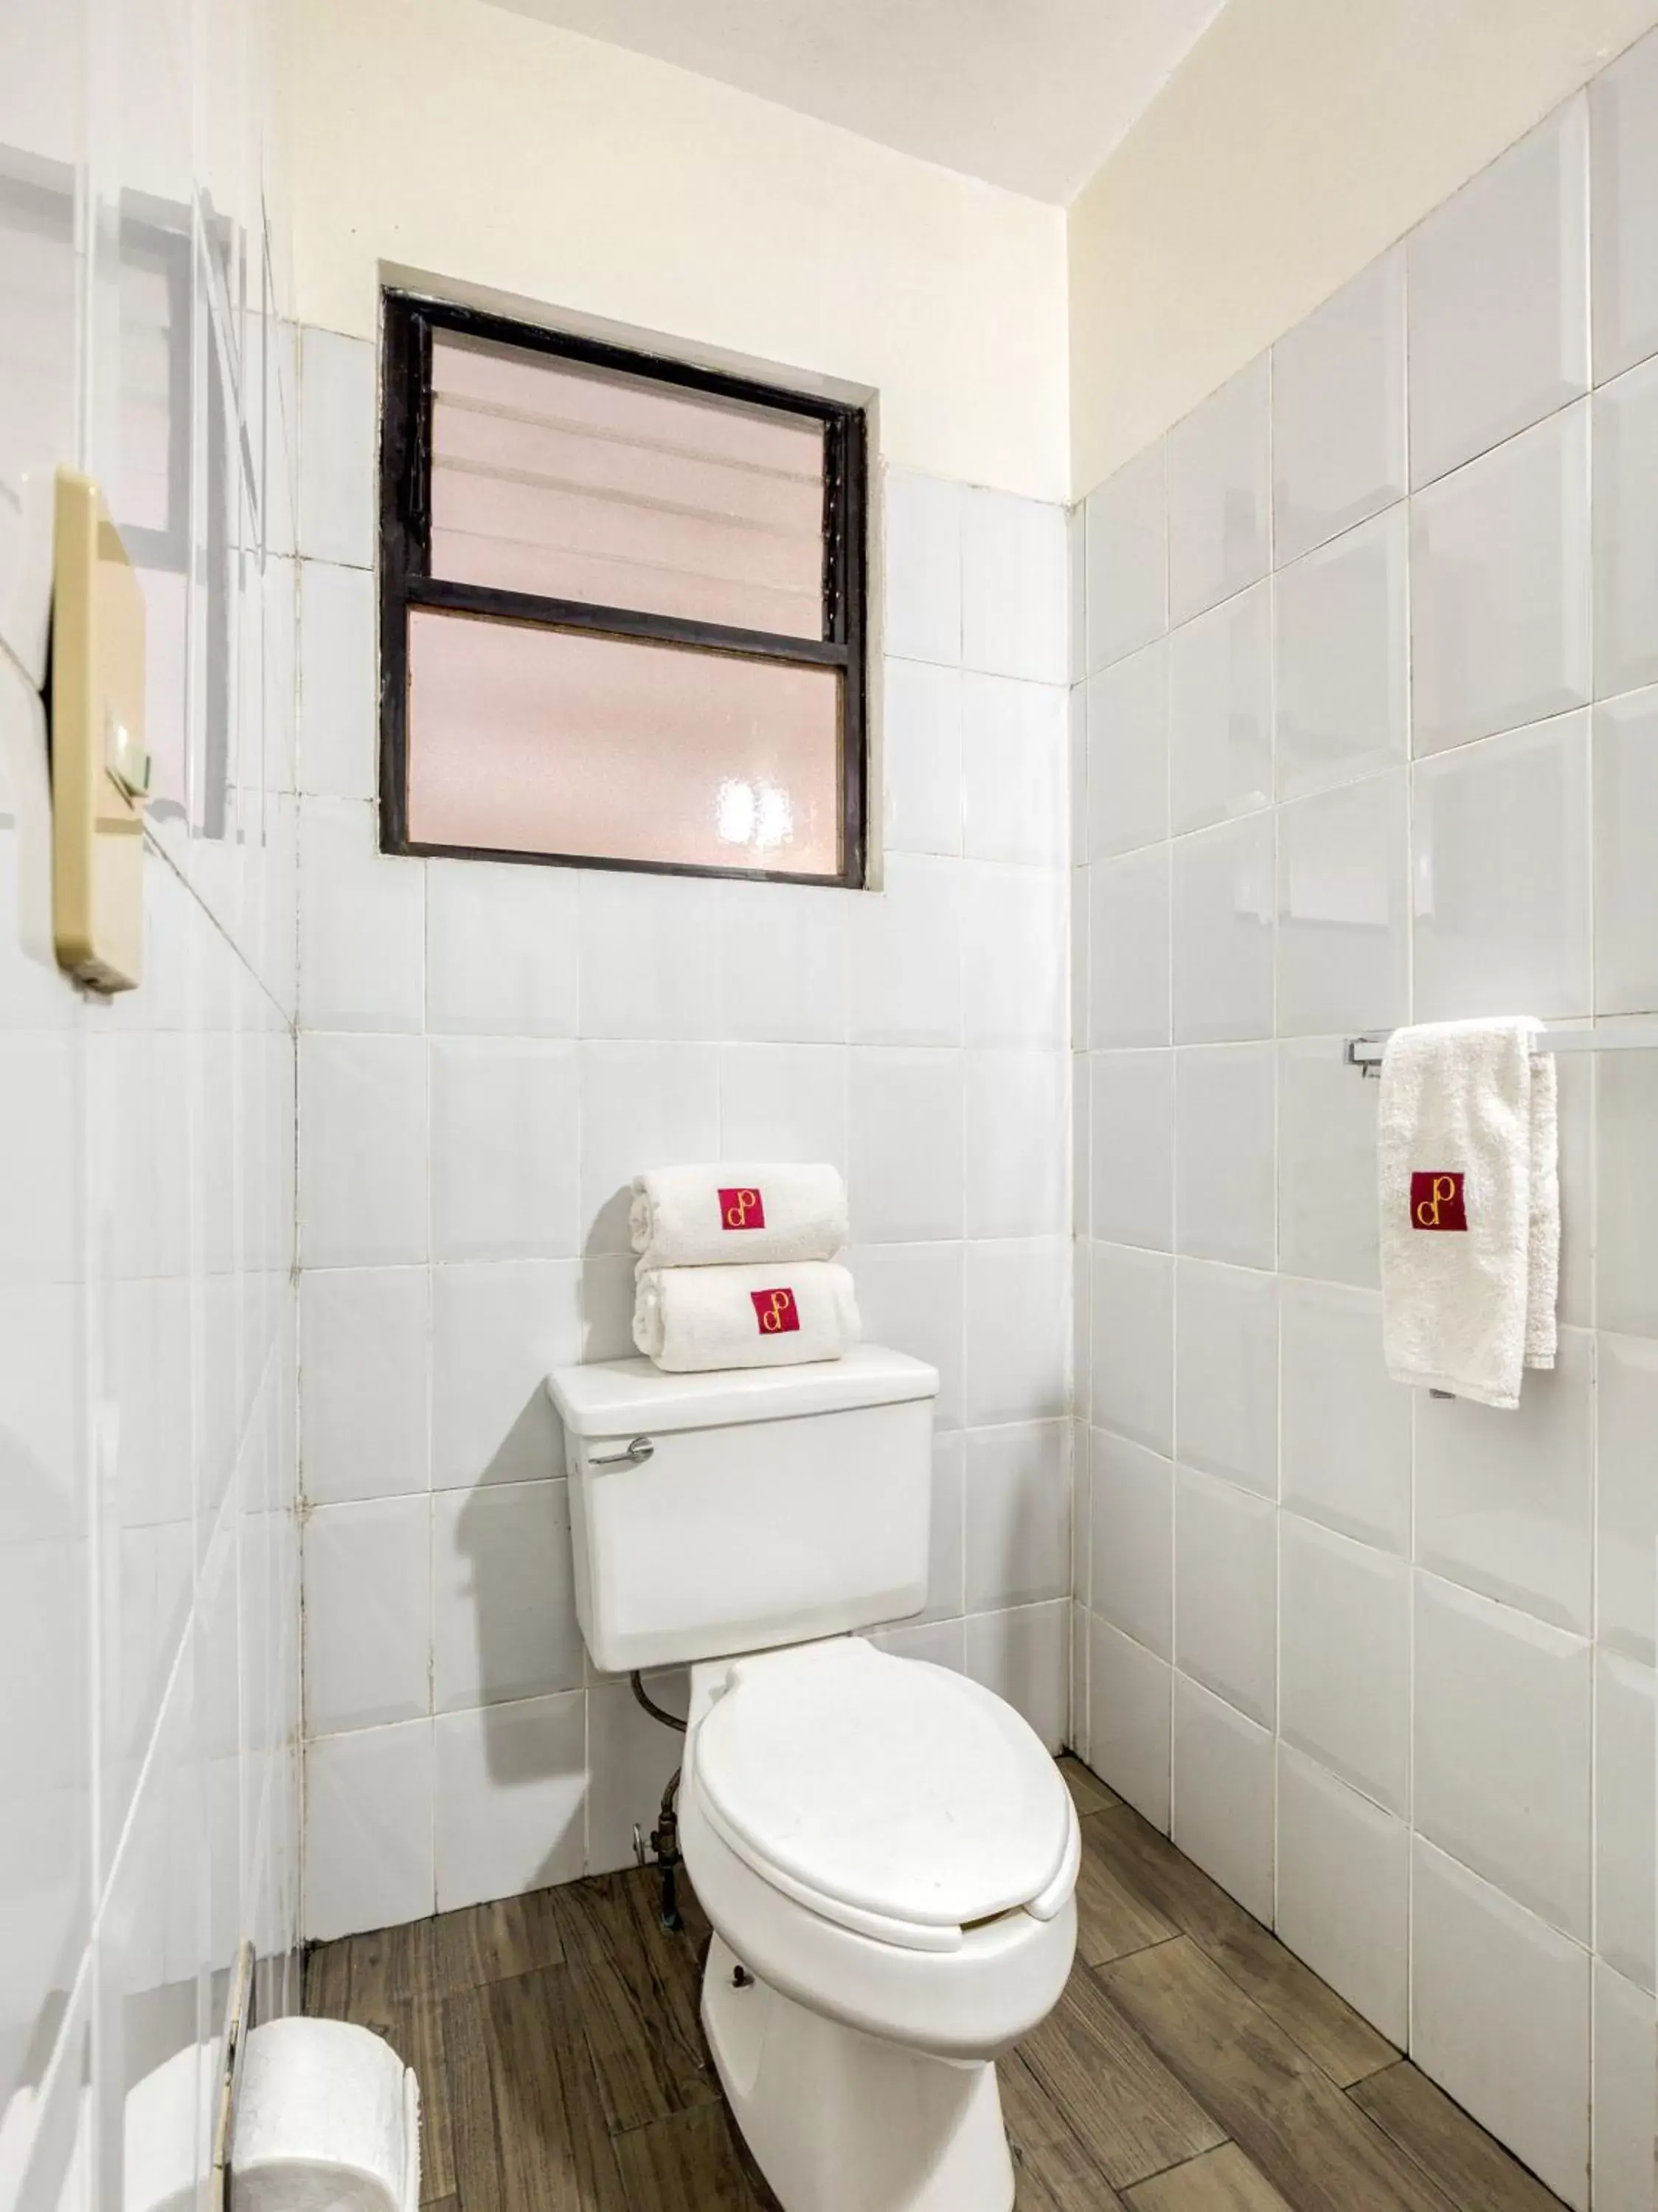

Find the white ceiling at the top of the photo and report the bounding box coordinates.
[478,0,1224,201]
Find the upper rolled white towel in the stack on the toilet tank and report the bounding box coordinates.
[628,1164,850,1270]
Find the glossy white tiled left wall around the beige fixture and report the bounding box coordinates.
[0,0,299,2212]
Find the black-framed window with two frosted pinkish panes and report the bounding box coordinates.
[381,294,864,885]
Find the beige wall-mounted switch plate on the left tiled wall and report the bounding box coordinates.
[51,469,150,991]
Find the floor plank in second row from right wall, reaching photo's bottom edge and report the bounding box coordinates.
[1106,1935,1461,2212]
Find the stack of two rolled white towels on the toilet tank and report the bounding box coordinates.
[628,1164,861,1374]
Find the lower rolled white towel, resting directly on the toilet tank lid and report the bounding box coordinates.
[633,1259,861,1374]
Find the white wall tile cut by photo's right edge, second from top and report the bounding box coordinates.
[1594,363,1658,699]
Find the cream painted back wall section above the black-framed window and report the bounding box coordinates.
[294,0,1067,500]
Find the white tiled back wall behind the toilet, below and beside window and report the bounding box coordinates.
[299,376,1069,1935]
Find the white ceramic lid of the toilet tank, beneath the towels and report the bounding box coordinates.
[547,1345,939,1436]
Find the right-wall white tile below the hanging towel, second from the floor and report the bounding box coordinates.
[1415,1573,1589,1942]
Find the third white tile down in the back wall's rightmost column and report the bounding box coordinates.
[961,860,1069,1046]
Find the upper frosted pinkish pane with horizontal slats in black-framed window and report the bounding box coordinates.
[431,334,823,637]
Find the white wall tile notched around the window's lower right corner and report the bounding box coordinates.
[850,854,961,1044]
